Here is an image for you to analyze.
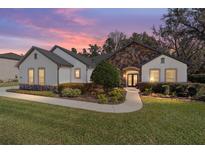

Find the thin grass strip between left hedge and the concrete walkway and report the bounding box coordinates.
[7,89,58,97]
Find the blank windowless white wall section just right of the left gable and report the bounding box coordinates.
[59,67,71,84]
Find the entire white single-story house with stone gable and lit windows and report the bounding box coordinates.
[17,41,187,86]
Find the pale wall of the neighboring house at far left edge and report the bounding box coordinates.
[0,58,19,81]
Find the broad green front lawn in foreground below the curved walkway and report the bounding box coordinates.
[0,97,205,144]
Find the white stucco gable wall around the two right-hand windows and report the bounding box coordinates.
[142,55,187,82]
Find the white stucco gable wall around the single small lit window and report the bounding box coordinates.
[53,48,87,83]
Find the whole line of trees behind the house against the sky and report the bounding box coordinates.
[72,9,205,74]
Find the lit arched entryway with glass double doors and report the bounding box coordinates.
[122,67,140,87]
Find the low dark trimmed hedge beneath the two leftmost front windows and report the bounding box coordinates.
[19,84,57,91]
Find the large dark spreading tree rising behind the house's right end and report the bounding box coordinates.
[154,9,205,73]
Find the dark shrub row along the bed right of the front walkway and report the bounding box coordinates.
[137,83,205,101]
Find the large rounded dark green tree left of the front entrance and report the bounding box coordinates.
[91,61,120,90]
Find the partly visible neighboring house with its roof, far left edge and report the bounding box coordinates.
[0,53,21,81]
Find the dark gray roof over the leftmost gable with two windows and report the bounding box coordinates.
[17,46,73,67]
